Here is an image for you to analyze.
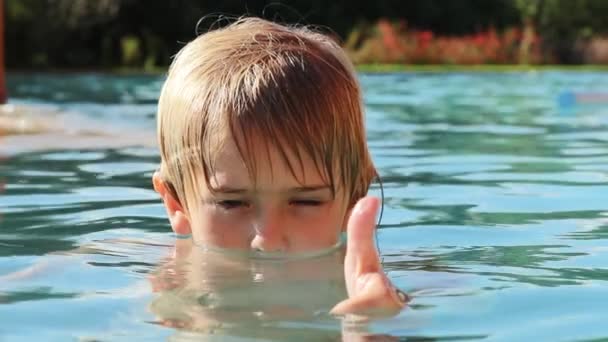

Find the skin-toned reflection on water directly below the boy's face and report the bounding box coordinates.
[150,241,346,340]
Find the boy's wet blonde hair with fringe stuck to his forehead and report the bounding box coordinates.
[158,18,376,214]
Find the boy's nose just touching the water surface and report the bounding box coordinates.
[251,211,287,252]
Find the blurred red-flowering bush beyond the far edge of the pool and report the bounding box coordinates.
[345,19,548,64]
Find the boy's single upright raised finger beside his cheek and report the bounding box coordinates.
[345,197,380,275]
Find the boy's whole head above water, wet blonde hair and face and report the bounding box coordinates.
[154,18,376,250]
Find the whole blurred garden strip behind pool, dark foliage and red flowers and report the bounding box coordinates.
[4,0,608,71]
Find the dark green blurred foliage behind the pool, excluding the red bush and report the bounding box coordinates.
[5,0,608,70]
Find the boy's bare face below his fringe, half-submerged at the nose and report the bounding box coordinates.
[161,140,349,253]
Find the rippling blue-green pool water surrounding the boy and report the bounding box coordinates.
[0,71,608,341]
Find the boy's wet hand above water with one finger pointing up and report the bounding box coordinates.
[331,197,409,316]
